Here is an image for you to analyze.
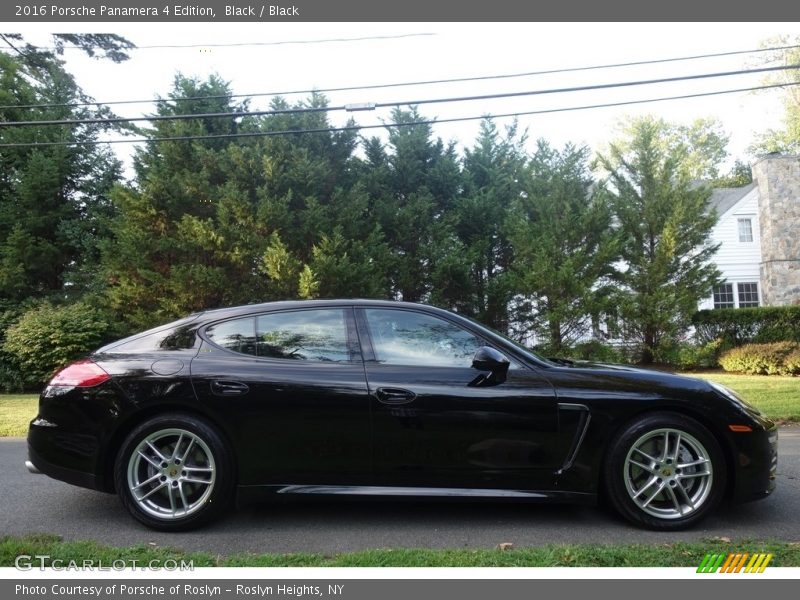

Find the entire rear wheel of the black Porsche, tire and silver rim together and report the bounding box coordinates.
[114,413,235,531]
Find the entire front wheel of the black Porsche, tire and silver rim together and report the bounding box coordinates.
[603,412,727,531]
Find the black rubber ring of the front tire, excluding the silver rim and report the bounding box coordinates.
[603,412,727,531]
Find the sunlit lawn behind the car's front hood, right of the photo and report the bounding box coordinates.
[685,371,800,421]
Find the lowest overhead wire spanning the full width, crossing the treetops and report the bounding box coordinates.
[0,82,800,148]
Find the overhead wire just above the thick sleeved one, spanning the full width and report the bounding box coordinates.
[0,43,800,109]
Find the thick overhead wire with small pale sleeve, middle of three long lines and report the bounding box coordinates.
[0,65,800,127]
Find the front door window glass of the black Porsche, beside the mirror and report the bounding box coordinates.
[365,309,481,367]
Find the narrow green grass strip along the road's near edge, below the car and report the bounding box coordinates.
[0,535,800,567]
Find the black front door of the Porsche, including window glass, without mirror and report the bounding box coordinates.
[357,307,564,489]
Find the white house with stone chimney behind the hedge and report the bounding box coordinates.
[699,155,800,309]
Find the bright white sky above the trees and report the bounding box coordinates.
[14,23,800,173]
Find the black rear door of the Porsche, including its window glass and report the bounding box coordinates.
[192,306,371,485]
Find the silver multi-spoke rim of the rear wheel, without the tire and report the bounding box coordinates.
[128,429,216,520]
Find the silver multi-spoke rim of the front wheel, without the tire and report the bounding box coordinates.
[623,429,714,519]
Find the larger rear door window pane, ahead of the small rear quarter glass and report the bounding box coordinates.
[256,309,350,362]
